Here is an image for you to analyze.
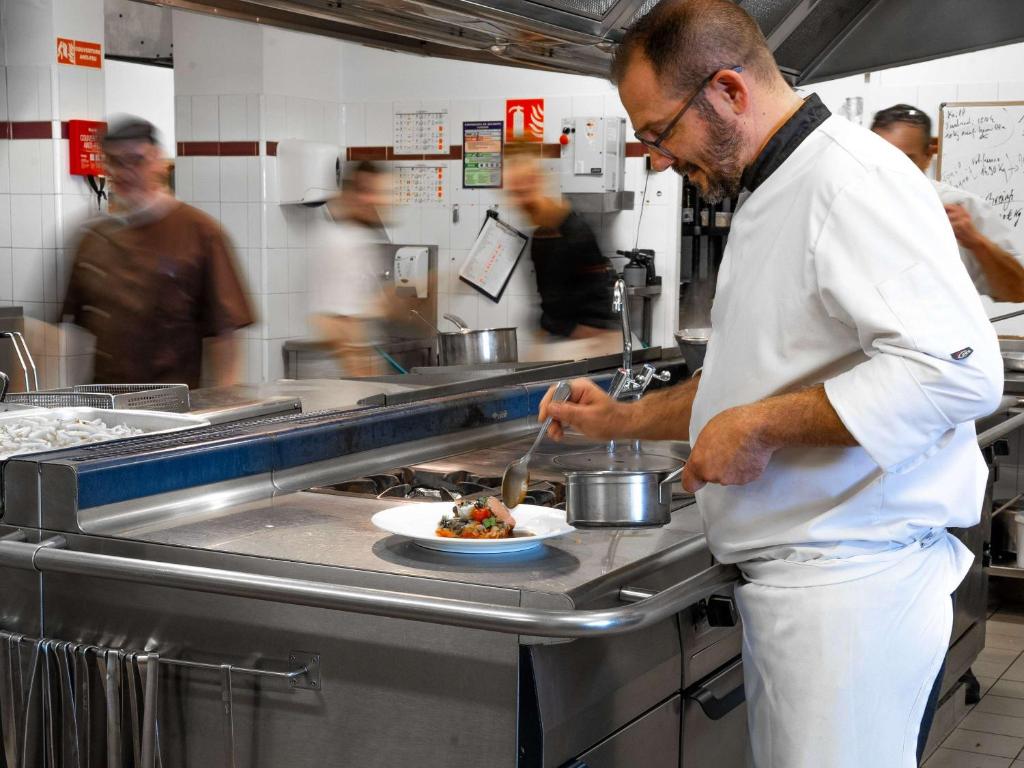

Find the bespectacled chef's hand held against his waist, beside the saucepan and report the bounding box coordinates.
[683,404,775,494]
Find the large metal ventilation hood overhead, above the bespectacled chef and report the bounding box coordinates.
[111,0,1024,85]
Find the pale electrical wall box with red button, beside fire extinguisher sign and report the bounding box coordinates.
[559,117,626,195]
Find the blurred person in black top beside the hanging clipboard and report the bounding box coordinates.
[503,143,622,358]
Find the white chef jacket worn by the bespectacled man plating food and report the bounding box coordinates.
[690,117,1002,579]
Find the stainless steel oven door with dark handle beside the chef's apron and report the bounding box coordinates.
[680,658,750,768]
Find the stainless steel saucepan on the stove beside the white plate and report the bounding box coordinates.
[565,467,683,528]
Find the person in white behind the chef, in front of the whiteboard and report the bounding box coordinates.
[871,104,1024,301]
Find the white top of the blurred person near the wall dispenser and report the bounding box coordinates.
[308,220,383,318]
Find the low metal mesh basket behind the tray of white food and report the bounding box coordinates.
[7,384,189,414]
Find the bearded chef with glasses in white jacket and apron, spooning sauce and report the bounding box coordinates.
[541,0,1002,768]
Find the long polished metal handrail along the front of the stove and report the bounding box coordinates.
[0,539,739,638]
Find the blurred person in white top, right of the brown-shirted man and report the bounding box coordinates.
[308,161,391,376]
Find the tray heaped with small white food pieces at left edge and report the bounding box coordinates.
[0,408,210,460]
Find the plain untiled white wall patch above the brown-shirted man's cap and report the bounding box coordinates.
[103,59,175,151]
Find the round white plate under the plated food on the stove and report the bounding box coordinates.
[372,502,575,554]
